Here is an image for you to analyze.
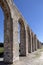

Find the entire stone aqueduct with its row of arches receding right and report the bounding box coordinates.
[0,0,41,63]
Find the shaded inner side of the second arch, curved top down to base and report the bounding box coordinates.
[18,18,26,56]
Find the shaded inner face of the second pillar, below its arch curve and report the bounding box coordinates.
[20,25,26,56]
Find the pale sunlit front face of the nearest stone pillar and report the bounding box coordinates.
[12,19,19,62]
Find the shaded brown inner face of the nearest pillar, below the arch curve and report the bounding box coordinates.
[4,17,13,63]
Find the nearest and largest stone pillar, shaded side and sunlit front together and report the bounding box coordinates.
[4,19,19,63]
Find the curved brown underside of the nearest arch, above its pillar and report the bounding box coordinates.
[0,0,11,18]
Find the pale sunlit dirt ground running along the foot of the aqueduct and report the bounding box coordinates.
[0,50,43,65]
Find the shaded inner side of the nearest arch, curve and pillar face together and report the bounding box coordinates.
[0,0,13,62]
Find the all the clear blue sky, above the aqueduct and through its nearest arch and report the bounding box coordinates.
[0,0,43,42]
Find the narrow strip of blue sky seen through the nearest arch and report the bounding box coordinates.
[0,7,4,42]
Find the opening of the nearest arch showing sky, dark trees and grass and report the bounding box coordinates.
[0,7,4,57]
